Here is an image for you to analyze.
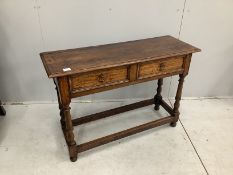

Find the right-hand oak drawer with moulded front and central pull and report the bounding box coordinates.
[138,57,183,79]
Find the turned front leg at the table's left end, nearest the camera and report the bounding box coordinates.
[58,77,78,162]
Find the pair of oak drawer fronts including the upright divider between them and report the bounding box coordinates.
[69,57,183,93]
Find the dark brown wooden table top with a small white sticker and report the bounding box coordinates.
[40,36,200,78]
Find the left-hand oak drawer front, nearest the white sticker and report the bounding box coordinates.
[70,66,129,92]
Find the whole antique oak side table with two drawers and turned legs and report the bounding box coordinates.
[40,36,200,161]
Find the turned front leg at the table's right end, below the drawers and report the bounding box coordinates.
[170,74,185,127]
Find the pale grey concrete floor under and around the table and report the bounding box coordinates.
[0,99,233,175]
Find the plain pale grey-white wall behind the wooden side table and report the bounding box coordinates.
[0,0,233,101]
